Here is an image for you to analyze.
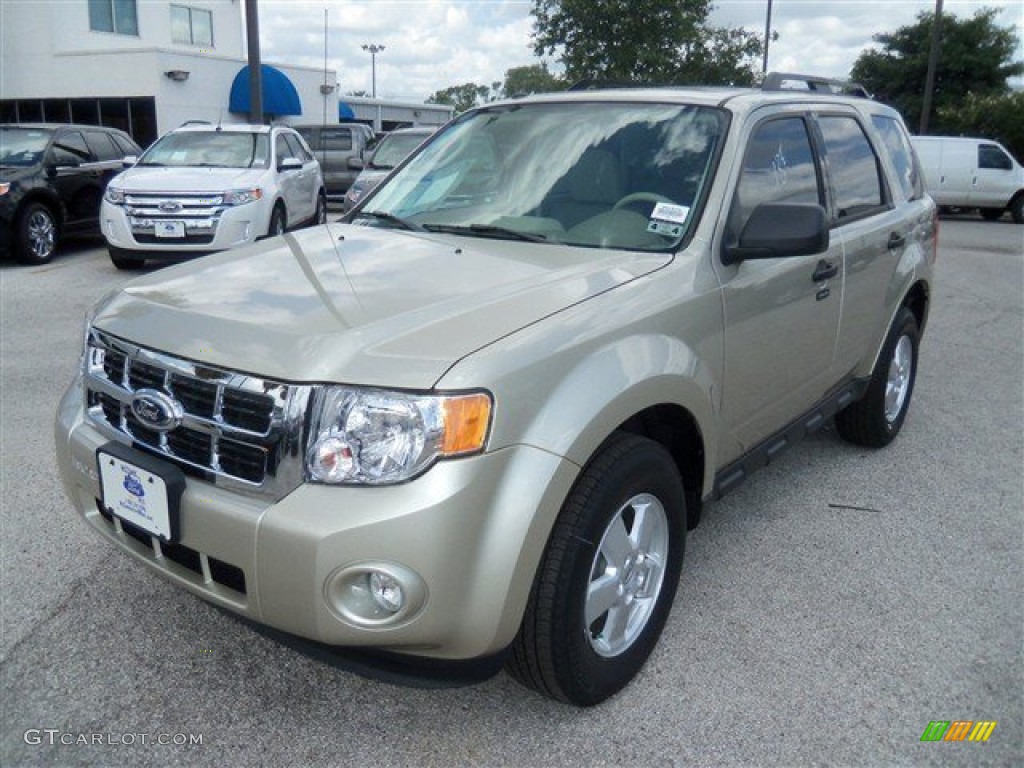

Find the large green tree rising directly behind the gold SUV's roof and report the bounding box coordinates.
[531,0,763,84]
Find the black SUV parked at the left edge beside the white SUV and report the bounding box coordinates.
[0,123,142,264]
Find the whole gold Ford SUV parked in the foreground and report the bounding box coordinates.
[56,78,937,706]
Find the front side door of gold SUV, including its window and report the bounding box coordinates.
[719,108,843,450]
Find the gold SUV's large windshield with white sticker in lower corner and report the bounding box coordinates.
[355,102,725,251]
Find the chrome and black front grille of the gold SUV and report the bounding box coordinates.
[84,329,311,500]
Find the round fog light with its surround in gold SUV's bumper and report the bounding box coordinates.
[324,562,427,629]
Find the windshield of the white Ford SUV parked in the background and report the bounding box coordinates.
[138,131,270,168]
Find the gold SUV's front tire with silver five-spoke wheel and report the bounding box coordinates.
[508,433,686,707]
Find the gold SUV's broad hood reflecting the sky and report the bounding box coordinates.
[93,223,672,389]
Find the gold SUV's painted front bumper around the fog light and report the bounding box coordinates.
[55,382,578,660]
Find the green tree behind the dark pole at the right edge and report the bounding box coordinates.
[850,8,1024,133]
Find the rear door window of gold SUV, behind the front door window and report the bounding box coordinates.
[819,116,885,220]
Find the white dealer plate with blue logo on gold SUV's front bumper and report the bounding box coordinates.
[96,449,172,541]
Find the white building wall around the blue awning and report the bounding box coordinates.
[0,0,338,140]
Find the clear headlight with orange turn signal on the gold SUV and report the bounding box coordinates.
[306,387,492,485]
